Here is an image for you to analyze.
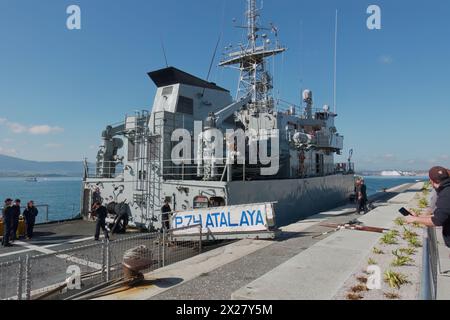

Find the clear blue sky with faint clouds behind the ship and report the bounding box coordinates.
[0,0,450,169]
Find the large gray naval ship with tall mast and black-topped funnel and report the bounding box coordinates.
[81,0,354,235]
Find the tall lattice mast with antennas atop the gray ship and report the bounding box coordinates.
[219,0,286,112]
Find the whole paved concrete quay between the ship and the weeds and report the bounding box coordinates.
[95,183,448,300]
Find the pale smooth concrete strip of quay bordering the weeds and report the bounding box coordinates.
[232,184,423,300]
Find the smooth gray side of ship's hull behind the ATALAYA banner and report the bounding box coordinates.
[227,175,355,227]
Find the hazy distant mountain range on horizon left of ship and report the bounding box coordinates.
[0,155,83,177]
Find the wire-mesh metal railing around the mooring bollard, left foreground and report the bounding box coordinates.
[0,226,202,300]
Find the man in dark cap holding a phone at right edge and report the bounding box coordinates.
[406,167,450,248]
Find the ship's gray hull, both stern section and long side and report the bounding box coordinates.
[82,175,354,229]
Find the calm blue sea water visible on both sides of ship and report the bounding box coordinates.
[0,177,426,222]
